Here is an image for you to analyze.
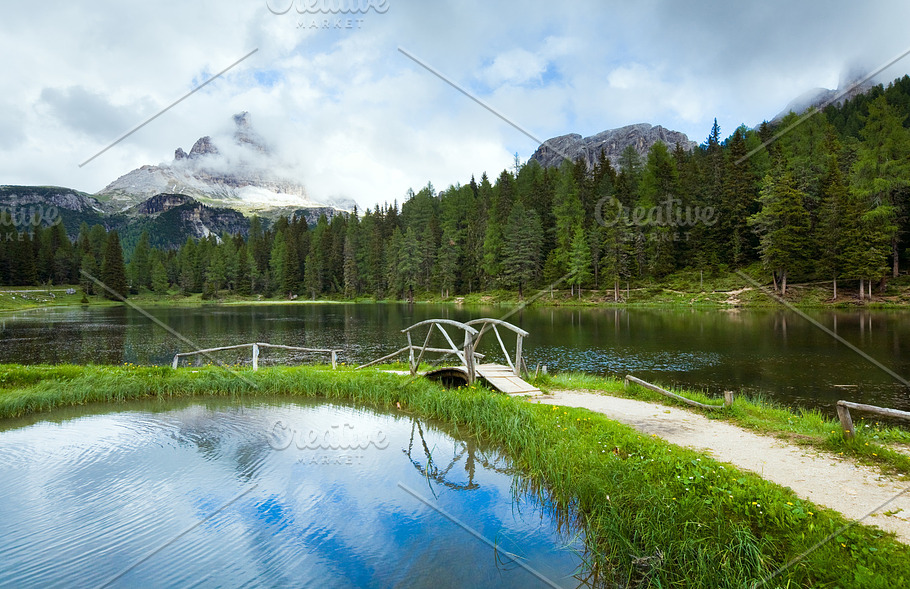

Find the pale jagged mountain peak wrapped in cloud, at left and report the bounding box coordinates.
[95,112,354,217]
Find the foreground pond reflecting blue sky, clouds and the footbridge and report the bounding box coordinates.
[0,401,583,588]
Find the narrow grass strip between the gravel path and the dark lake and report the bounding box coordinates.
[536,372,910,479]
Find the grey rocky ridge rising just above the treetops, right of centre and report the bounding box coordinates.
[531,123,697,170]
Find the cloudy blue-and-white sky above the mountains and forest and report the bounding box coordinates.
[0,0,910,206]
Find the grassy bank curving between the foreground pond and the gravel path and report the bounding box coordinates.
[0,365,910,588]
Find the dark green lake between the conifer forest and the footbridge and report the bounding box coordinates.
[0,304,910,413]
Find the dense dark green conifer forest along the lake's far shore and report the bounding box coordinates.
[0,76,910,299]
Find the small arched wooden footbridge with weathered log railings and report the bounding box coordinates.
[357,318,540,395]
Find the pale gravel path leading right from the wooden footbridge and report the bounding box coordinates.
[529,391,910,544]
